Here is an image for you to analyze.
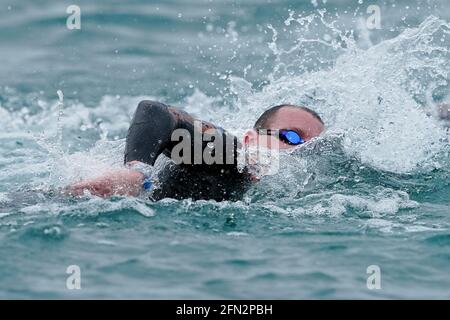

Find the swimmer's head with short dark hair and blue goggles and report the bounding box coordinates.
[244,104,325,149]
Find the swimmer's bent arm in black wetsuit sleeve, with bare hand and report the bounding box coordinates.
[66,101,234,197]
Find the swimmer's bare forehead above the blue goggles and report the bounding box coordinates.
[269,106,325,136]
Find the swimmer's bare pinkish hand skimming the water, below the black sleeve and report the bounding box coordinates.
[64,168,144,197]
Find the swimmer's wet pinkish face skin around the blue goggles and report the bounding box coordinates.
[244,106,325,150]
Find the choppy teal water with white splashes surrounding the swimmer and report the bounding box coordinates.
[0,0,450,299]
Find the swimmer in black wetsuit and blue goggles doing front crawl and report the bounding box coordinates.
[66,101,325,201]
